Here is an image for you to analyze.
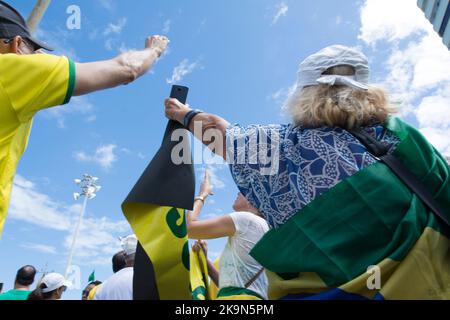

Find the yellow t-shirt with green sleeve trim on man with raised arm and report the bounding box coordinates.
[0,54,75,235]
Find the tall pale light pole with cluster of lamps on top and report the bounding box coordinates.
[64,174,101,278]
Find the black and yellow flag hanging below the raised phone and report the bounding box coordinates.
[122,121,195,300]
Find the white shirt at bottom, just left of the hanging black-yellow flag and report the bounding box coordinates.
[94,267,133,300]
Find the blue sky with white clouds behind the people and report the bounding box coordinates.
[0,0,450,299]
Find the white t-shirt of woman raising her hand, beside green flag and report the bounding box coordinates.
[219,212,269,299]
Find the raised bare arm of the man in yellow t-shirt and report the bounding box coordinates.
[73,36,168,96]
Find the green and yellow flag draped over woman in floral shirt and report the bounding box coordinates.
[251,118,450,300]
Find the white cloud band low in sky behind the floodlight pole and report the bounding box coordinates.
[9,175,131,265]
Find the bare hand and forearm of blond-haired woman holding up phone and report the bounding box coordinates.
[165,98,230,160]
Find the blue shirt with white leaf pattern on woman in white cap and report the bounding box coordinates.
[227,125,400,228]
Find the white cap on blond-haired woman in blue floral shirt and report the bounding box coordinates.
[296,45,370,91]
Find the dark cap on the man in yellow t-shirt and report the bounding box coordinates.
[0,0,53,51]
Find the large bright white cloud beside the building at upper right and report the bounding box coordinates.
[359,0,450,156]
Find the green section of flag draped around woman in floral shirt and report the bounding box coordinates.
[251,118,450,287]
